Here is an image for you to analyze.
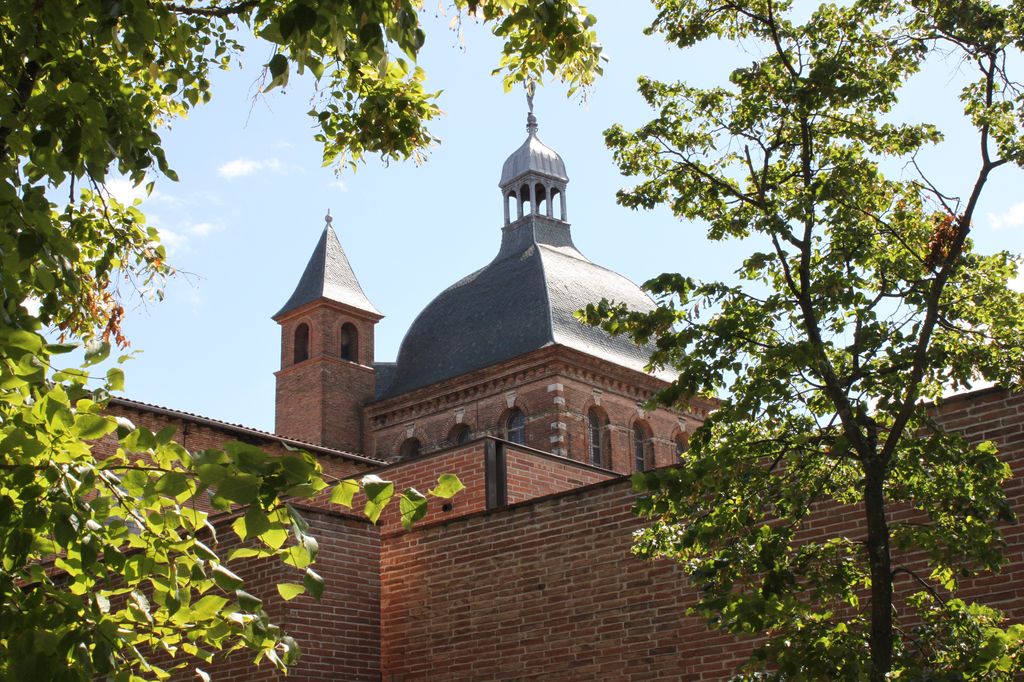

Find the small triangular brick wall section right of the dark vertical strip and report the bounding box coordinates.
[505,445,615,504]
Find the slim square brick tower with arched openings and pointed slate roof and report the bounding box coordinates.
[273,213,383,453]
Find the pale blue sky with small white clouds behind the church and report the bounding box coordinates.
[99,1,1024,430]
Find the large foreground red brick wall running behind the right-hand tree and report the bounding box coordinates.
[381,391,1024,682]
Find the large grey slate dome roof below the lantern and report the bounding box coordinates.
[381,215,654,397]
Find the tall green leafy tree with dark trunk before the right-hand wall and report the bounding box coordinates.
[584,0,1024,680]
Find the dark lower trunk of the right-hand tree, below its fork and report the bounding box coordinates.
[864,458,893,682]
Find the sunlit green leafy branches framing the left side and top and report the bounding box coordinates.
[0,0,600,680]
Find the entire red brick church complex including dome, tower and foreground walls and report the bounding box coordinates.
[103,109,1024,682]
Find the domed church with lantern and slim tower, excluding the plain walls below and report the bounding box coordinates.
[273,114,709,473]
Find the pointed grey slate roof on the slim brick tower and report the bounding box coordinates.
[273,222,381,319]
